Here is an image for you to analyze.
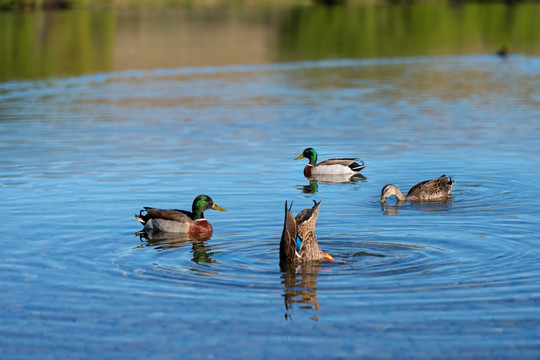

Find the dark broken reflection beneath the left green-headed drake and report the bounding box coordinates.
[136,230,216,264]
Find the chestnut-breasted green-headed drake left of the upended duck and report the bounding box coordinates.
[135,195,227,234]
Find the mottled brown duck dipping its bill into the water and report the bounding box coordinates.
[381,175,456,203]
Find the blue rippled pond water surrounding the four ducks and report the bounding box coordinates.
[0,3,540,359]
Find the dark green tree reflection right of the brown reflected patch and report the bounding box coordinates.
[279,3,540,60]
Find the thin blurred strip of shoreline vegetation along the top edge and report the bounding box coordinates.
[0,0,540,11]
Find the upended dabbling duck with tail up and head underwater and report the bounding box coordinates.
[279,201,334,266]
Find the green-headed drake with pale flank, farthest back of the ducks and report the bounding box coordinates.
[294,148,366,177]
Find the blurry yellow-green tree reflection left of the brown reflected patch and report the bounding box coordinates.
[0,11,115,80]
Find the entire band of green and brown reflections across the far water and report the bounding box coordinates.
[0,3,540,81]
